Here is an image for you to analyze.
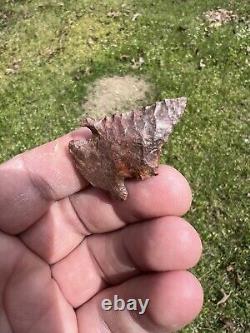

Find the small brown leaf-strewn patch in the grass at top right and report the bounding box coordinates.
[204,8,238,27]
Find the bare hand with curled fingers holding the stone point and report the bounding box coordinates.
[0,128,203,333]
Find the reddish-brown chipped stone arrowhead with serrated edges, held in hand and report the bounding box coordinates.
[69,97,187,200]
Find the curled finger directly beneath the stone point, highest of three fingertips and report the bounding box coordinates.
[71,165,192,233]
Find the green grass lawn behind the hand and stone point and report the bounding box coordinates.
[0,0,250,333]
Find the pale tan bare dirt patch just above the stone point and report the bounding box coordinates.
[82,75,152,117]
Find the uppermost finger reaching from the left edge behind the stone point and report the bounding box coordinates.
[0,128,89,234]
